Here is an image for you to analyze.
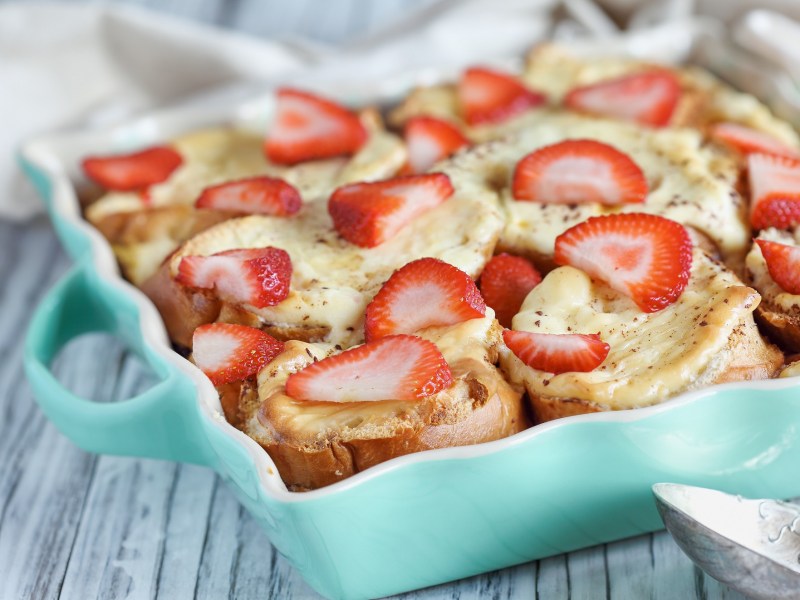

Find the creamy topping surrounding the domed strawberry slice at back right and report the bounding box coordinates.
[439,111,750,260]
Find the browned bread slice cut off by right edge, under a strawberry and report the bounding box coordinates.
[745,228,800,353]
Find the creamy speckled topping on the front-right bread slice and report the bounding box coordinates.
[501,249,759,410]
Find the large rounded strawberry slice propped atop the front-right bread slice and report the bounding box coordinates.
[555,213,692,312]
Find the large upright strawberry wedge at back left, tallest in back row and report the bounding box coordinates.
[264,88,367,165]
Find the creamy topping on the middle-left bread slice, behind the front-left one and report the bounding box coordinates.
[170,169,503,345]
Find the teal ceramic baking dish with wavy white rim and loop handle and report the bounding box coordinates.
[20,81,800,599]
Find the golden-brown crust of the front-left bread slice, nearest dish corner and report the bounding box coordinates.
[239,344,530,491]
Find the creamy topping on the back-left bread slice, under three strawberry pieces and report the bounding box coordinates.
[86,112,406,223]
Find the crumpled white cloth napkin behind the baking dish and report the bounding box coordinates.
[0,0,800,219]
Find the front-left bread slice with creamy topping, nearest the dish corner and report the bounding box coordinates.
[237,310,529,491]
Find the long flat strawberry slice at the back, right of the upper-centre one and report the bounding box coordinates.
[564,71,681,127]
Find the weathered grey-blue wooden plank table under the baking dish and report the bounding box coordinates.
[0,0,742,600]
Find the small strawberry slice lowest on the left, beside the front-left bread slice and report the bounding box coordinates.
[192,323,283,385]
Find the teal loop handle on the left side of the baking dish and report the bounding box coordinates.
[24,264,213,466]
